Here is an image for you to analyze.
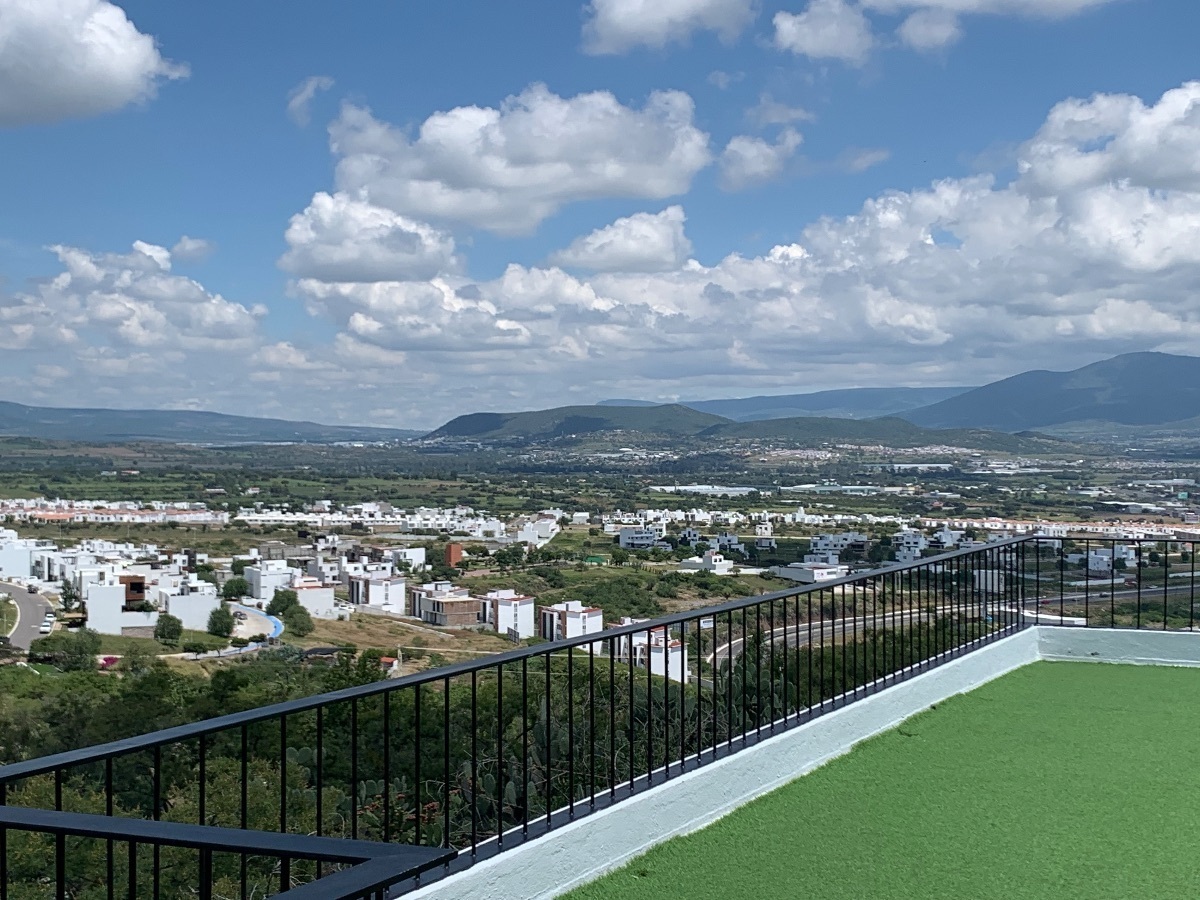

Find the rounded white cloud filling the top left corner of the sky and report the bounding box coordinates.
[0,0,187,126]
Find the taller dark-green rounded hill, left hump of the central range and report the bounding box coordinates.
[426,404,728,440]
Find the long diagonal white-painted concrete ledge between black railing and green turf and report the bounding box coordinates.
[409,628,1041,900]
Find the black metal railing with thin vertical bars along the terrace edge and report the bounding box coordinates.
[0,538,1195,900]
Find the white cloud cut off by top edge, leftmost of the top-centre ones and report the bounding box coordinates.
[583,0,755,54]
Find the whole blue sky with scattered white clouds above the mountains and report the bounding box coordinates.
[0,0,1200,428]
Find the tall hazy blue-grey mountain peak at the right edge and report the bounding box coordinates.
[901,353,1200,431]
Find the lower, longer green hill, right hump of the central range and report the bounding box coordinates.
[701,416,1063,452]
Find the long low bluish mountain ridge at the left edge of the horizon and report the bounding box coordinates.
[0,401,422,444]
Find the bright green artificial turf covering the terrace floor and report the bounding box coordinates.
[568,662,1200,900]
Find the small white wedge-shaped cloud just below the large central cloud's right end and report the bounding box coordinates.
[550,206,691,272]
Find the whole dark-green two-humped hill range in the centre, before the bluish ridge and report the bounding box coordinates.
[427,404,1062,452]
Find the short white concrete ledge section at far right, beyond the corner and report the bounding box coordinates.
[1034,626,1200,666]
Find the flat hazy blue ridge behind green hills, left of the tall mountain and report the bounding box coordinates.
[600,388,971,422]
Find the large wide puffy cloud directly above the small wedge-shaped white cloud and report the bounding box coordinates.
[330,84,712,234]
